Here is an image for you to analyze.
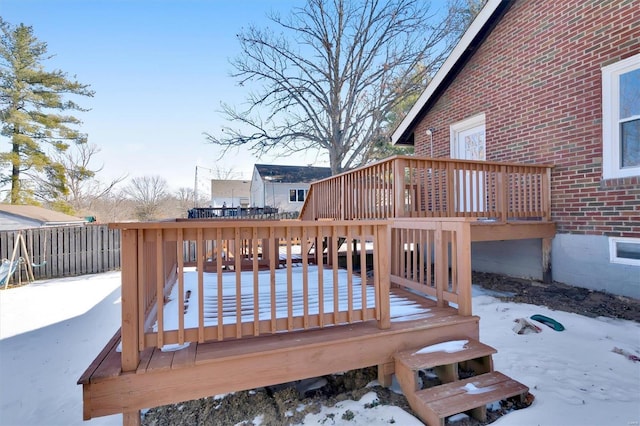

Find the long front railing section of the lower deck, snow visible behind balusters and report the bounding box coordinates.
[110,220,390,371]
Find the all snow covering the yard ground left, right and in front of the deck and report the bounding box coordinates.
[0,272,640,426]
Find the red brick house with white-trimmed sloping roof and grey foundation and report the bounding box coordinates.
[392,0,640,298]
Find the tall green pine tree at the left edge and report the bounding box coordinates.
[0,18,94,204]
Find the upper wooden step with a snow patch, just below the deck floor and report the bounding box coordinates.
[394,339,497,392]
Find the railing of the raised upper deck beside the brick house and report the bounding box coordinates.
[300,156,551,222]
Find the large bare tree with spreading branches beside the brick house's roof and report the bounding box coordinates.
[206,0,456,173]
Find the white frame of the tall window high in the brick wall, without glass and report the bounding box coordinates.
[602,54,640,179]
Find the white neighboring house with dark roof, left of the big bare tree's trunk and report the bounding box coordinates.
[251,164,331,212]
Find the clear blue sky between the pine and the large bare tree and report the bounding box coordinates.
[0,0,326,191]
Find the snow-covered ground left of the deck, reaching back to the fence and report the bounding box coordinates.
[0,272,122,426]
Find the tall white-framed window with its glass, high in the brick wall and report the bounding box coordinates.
[602,54,640,179]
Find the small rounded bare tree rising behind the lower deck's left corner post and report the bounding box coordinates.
[124,176,167,220]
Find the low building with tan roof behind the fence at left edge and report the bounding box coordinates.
[0,204,85,231]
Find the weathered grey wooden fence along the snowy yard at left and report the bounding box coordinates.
[0,224,120,281]
